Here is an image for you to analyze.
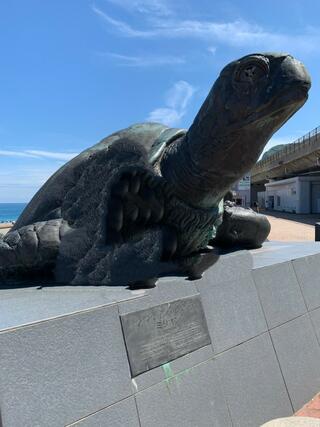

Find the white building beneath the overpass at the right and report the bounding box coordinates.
[260,176,320,214]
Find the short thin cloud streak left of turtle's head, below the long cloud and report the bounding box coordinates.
[99,52,186,67]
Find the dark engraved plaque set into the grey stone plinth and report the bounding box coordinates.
[121,296,211,376]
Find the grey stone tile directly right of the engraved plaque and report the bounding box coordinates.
[197,272,267,354]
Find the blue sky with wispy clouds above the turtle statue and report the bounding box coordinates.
[0,0,320,202]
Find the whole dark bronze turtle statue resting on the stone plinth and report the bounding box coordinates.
[0,53,311,286]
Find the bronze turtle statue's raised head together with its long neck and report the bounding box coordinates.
[161,53,311,207]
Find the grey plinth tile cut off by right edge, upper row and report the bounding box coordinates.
[292,254,320,310]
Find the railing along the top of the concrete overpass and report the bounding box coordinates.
[253,126,320,173]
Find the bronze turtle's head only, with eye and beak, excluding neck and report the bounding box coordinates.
[212,53,311,135]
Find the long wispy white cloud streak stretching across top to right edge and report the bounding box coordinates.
[93,6,320,53]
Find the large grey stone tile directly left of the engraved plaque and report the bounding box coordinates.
[0,305,132,427]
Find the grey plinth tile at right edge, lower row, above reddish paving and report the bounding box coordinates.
[271,315,320,411]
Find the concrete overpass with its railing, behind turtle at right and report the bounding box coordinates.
[251,127,320,185]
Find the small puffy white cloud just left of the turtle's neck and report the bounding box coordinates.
[147,80,195,126]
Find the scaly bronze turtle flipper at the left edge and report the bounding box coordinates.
[0,219,69,280]
